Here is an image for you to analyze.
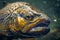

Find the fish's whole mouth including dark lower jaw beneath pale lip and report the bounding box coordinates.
[27,20,50,36]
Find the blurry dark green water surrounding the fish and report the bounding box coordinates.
[0,0,60,40]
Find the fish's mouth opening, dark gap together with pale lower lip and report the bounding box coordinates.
[30,21,50,32]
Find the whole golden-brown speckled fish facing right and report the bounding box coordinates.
[0,2,50,38]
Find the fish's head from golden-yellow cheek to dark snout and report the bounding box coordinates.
[11,3,51,37]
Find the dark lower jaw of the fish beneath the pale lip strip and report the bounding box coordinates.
[27,27,50,37]
